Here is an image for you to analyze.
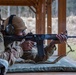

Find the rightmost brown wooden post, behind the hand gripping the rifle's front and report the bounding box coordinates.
[58,0,66,55]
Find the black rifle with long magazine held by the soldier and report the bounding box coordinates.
[4,33,76,60]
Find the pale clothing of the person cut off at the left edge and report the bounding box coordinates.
[0,32,8,75]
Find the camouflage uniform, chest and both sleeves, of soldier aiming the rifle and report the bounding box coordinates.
[2,39,55,65]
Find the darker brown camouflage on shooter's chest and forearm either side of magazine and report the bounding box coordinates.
[21,44,56,62]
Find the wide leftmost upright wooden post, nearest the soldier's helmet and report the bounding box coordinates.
[36,0,45,34]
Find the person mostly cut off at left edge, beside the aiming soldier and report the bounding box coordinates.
[0,32,8,75]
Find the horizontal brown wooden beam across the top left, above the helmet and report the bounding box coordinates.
[0,0,33,6]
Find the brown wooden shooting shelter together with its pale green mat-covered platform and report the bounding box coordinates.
[0,0,76,75]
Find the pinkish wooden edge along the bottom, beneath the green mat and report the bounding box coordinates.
[6,72,76,75]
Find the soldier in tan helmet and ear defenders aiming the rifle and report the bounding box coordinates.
[2,15,66,65]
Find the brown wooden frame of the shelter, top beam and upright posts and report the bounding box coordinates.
[0,0,66,56]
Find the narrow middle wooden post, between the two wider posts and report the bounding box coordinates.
[46,0,52,44]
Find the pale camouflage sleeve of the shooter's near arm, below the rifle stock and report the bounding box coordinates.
[1,42,23,65]
